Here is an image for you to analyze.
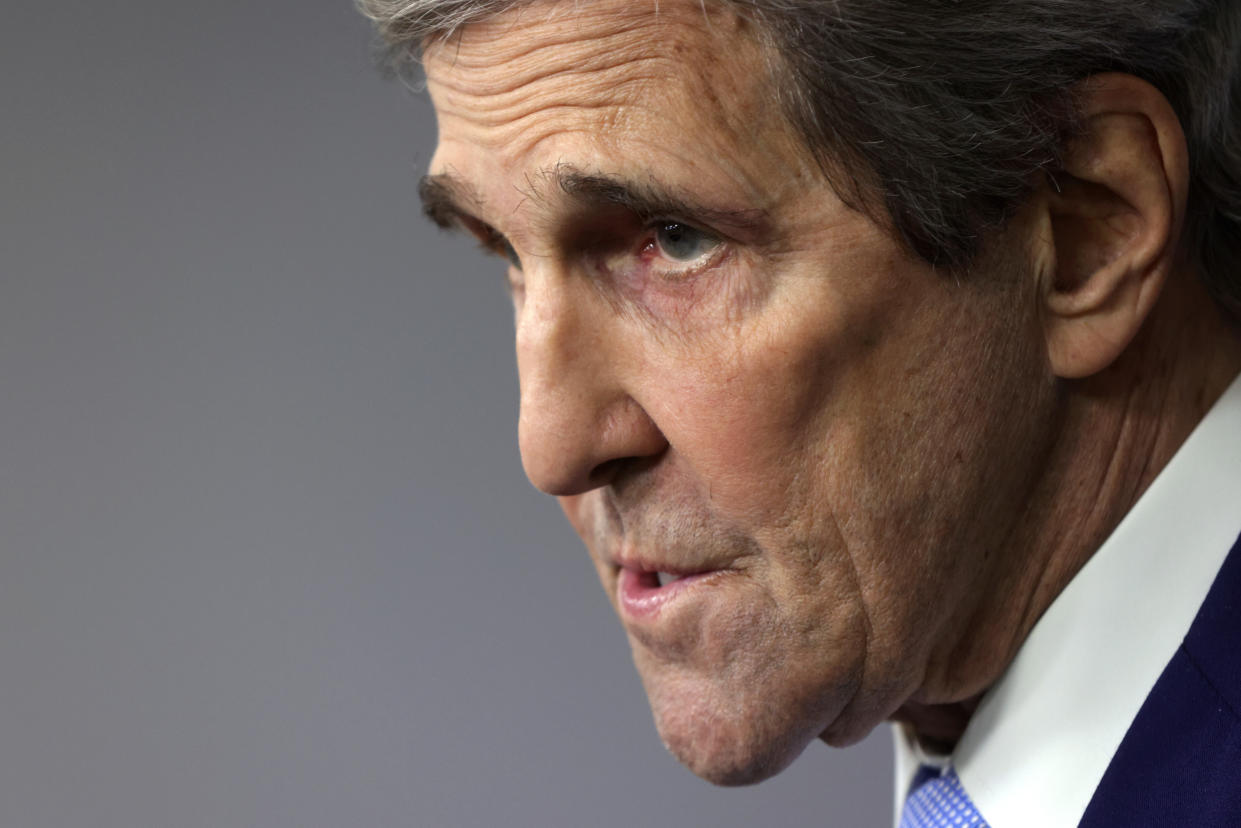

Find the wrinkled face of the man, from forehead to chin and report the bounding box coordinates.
[426,0,1051,783]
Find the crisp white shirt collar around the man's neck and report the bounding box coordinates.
[895,377,1241,828]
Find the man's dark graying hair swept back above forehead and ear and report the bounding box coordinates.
[357,0,1241,319]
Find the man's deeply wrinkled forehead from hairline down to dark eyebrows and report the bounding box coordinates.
[428,0,813,238]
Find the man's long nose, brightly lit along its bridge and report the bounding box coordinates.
[516,273,668,497]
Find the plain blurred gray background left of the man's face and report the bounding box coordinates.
[0,0,891,828]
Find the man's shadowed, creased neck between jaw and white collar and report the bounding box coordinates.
[896,269,1241,751]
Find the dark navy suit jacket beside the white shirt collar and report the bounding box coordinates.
[1080,539,1241,828]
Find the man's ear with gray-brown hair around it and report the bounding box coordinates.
[1041,74,1189,379]
